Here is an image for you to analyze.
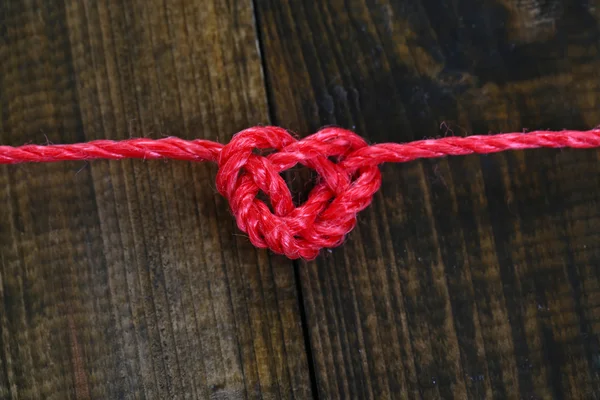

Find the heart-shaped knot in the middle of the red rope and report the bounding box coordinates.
[216,126,381,260]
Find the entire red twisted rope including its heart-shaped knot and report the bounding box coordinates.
[0,126,600,260]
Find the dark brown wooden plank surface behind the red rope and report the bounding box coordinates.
[0,0,600,399]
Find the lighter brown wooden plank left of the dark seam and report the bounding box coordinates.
[0,0,310,399]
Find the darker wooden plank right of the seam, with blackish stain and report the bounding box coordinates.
[257,0,600,399]
